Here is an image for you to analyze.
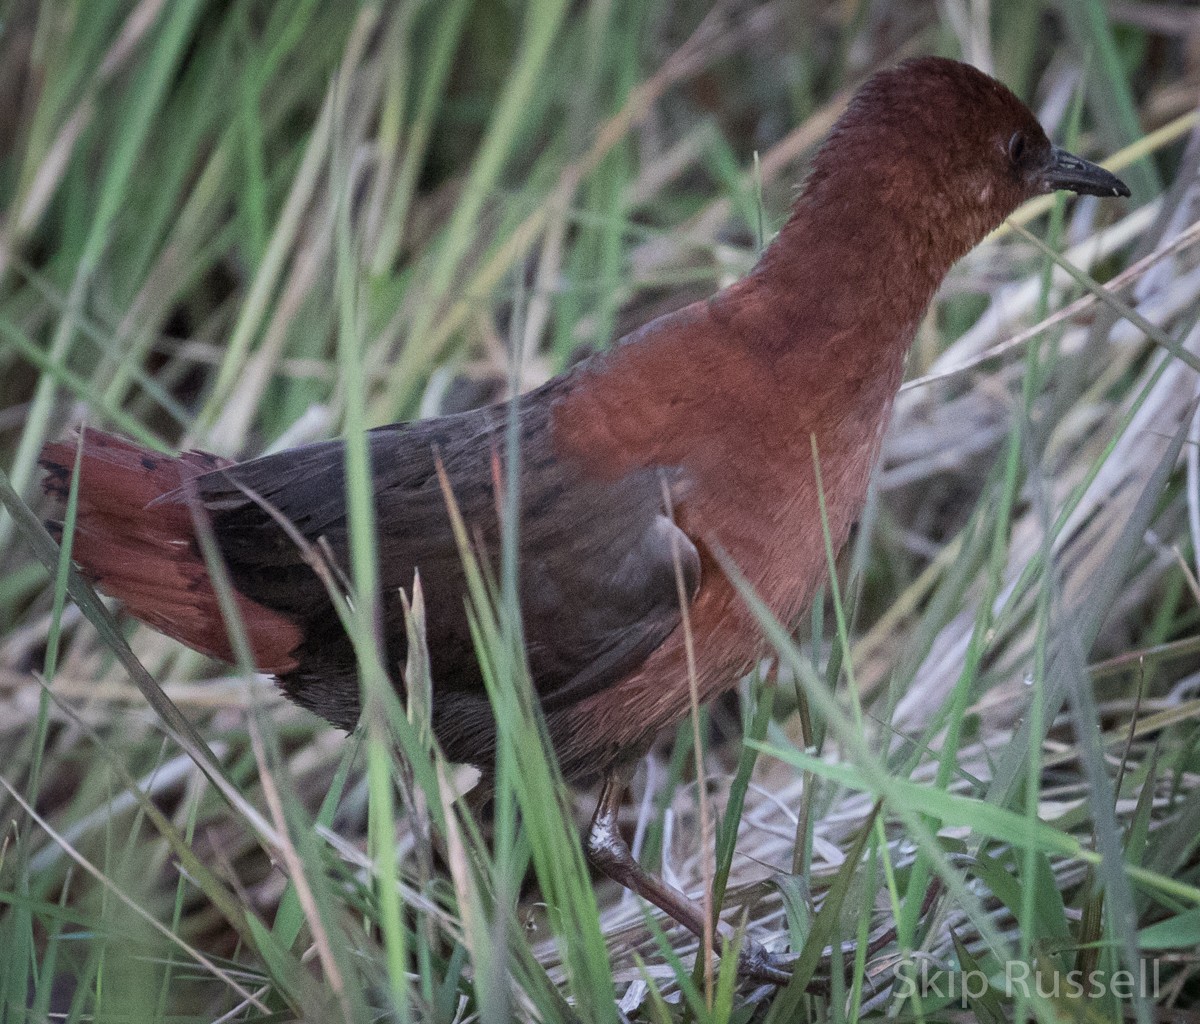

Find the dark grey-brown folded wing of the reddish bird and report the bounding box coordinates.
[197,395,700,715]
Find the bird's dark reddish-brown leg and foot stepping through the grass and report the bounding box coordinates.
[584,766,791,984]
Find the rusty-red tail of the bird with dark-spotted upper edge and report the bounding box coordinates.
[40,430,301,673]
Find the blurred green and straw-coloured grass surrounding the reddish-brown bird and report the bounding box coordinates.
[0,0,1200,1022]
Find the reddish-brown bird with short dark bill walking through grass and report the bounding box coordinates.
[41,56,1130,982]
